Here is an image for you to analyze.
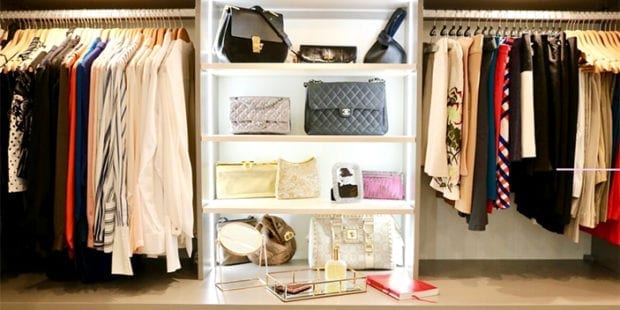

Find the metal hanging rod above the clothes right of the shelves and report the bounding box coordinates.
[424,10,620,21]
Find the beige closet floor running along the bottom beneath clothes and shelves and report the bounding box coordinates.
[0,260,620,310]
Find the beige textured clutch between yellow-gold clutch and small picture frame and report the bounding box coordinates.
[276,157,321,199]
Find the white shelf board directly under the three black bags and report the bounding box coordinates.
[202,63,416,76]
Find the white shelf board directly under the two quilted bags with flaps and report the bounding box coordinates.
[202,135,415,143]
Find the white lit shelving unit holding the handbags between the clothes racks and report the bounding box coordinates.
[200,0,420,306]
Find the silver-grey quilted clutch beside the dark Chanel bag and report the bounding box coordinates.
[230,96,291,134]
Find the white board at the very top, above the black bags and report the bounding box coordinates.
[209,0,410,11]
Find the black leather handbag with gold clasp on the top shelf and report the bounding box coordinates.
[216,5,292,62]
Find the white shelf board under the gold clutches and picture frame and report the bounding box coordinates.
[203,198,413,214]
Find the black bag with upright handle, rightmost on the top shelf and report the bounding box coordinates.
[364,8,407,63]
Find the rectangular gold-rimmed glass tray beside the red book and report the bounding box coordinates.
[265,268,367,302]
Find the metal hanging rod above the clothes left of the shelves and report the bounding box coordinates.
[0,9,196,20]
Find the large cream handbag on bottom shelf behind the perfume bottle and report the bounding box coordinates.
[308,214,396,269]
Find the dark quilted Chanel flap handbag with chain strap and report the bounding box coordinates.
[304,79,388,135]
